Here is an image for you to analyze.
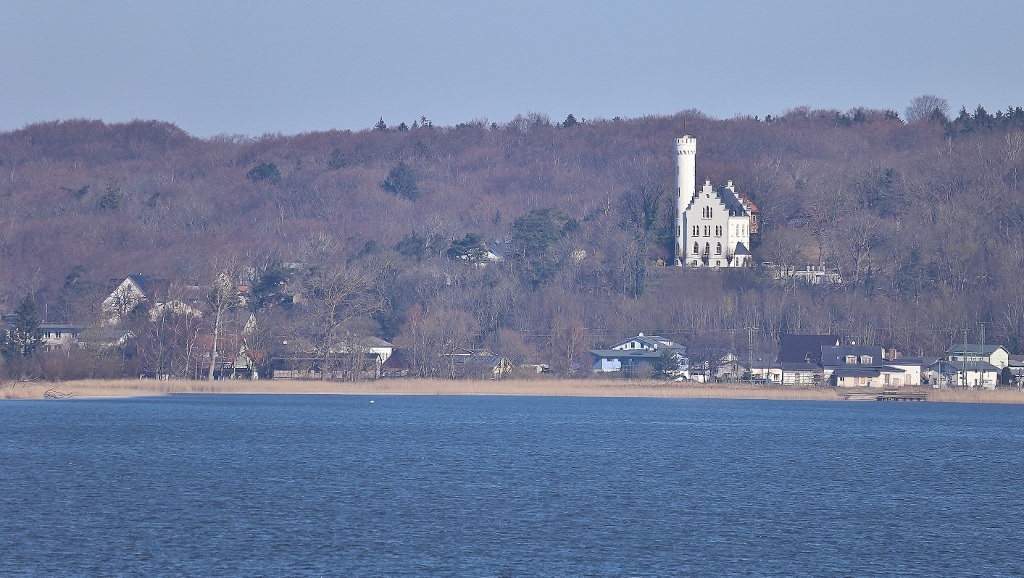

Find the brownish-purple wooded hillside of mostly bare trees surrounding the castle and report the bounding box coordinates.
[0,97,1024,375]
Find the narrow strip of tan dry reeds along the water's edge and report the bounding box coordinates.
[0,378,1024,404]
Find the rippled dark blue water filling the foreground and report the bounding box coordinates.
[0,396,1024,576]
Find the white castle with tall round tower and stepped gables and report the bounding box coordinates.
[676,134,758,267]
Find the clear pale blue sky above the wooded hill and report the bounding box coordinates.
[0,0,1024,136]
